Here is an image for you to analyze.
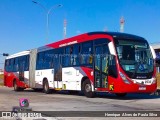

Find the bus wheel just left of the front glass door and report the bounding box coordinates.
[82,79,94,98]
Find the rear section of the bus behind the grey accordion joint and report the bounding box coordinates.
[4,51,30,91]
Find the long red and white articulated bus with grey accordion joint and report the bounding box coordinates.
[4,32,157,97]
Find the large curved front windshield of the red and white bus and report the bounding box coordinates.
[115,40,154,79]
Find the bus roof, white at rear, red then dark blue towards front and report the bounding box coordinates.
[6,31,145,59]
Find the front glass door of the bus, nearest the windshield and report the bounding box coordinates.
[94,44,109,88]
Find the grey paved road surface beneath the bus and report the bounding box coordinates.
[0,87,160,120]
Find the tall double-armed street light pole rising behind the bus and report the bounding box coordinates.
[32,1,62,41]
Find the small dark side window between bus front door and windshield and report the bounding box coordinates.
[108,55,118,78]
